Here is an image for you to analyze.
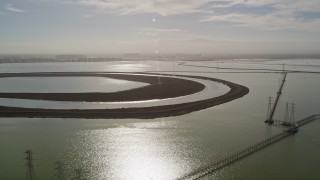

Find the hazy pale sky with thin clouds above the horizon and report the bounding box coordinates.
[0,0,320,54]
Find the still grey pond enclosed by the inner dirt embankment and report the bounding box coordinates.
[0,77,148,93]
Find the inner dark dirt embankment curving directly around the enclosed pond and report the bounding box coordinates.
[0,73,205,102]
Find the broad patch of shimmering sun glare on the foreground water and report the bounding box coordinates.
[71,127,183,180]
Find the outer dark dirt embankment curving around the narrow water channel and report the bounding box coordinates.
[0,72,249,119]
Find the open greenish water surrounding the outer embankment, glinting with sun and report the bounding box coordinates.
[0,60,320,179]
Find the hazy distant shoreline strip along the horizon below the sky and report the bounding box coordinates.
[0,53,320,64]
